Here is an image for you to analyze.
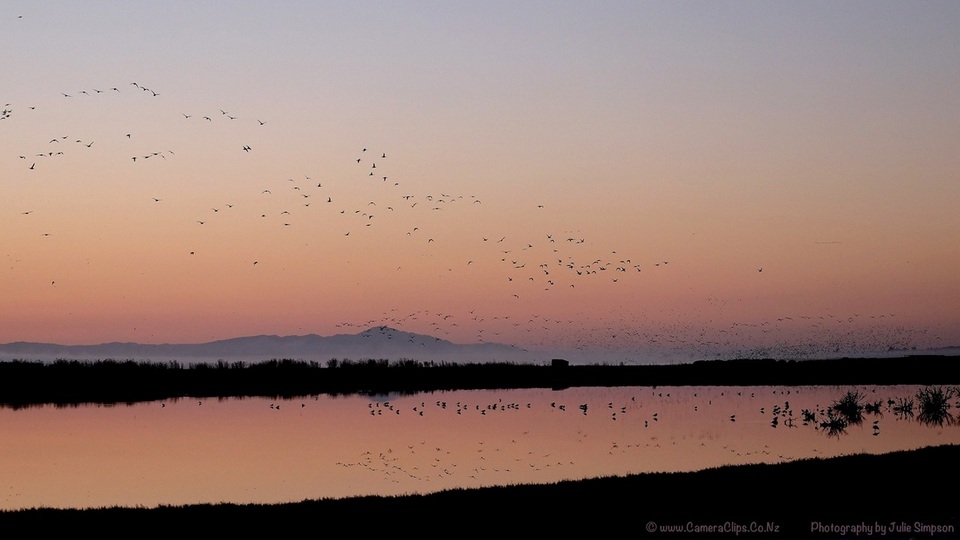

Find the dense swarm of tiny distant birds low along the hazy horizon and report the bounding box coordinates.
[328,309,924,363]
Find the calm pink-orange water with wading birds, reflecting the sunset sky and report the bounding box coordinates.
[0,386,960,509]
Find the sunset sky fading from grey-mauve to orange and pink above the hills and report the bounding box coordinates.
[0,1,960,358]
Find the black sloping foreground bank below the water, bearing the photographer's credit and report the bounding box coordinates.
[0,445,960,538]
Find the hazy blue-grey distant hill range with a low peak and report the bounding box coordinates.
[0,326,533,362]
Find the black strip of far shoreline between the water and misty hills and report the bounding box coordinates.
[0,356,960,408]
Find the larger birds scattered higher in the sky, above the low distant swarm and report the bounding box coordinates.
[0,81,688,350]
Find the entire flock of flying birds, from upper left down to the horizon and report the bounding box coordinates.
[0,77,926,359]
